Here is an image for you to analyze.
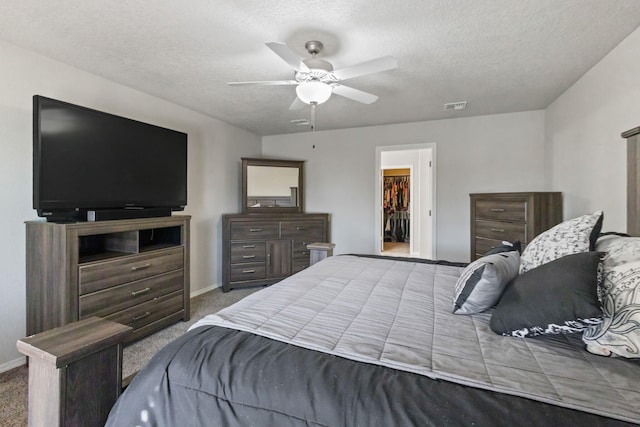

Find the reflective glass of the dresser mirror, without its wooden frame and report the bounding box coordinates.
[247,166,299,208]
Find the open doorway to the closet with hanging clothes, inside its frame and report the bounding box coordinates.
[375,144,436,259]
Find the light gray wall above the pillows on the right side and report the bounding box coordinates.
[546,29,640,231]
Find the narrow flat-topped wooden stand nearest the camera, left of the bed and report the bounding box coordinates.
[17,317,132,427]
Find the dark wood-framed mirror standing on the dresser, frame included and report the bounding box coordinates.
[242,157,304,214]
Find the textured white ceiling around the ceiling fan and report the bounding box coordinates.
[0,0,640,135]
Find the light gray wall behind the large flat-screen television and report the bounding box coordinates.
[0,42,261,372]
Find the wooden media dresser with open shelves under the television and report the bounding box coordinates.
[26,215,190,341]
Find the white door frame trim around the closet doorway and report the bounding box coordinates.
[374,143,437,259]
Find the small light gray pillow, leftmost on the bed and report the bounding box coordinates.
[453,251,520,314]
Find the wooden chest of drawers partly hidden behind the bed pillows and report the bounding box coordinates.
[469,192,562,261]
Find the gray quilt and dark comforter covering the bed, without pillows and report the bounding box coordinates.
[108,256,640,426]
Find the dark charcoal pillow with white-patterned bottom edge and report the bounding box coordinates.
[489,252,602,337]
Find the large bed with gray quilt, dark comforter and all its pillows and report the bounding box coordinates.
[107,128,640,426]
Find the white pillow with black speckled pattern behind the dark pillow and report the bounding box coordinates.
[520,211,604,274]
